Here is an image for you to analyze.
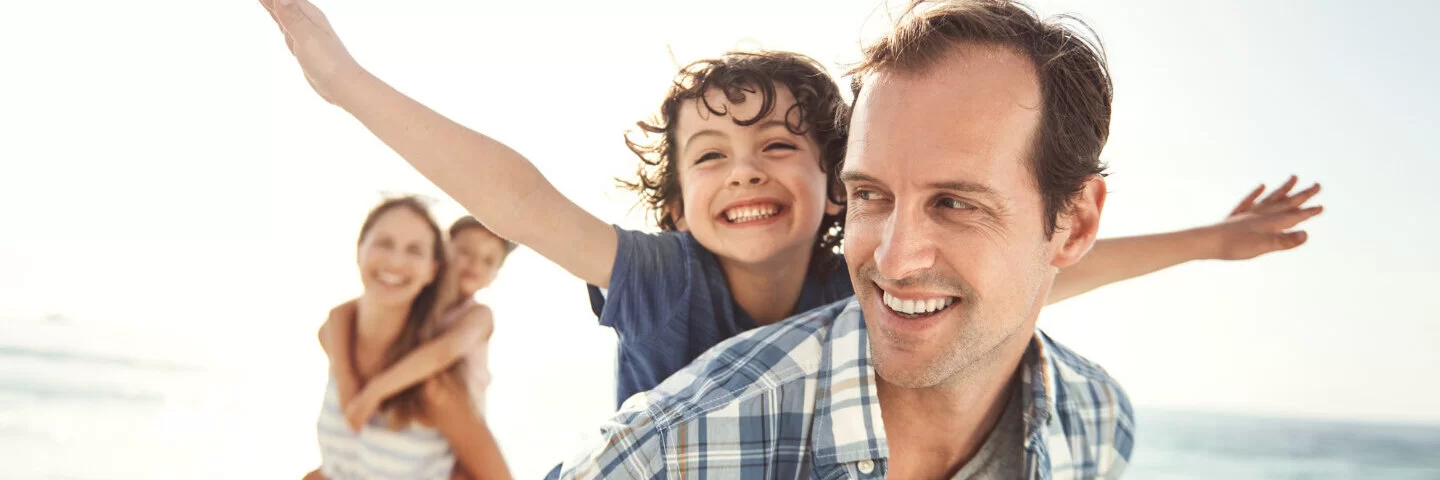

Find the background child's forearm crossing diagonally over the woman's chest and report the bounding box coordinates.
[344,306,494,431]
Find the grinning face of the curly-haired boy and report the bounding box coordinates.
[675,85,840,264]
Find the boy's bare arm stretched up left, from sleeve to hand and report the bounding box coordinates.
[261,0,618,288]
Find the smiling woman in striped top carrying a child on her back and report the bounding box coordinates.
[307,197,508,479]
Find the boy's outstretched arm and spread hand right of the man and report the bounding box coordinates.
[1045,176,1323,303]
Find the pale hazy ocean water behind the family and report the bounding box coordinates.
[0,334,1440,479]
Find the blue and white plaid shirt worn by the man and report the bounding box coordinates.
[562,300,1135,479]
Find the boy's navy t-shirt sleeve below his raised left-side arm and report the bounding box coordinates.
[588,226,690,333]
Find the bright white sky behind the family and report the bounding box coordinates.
[0,0,1440,473]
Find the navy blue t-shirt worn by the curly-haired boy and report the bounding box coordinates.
[589,226,855,405]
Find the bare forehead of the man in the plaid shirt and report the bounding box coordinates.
[845,45,1041,196]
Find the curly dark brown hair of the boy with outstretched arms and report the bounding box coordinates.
[616,50,850,275]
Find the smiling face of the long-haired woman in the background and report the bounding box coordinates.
[356,208,439,306]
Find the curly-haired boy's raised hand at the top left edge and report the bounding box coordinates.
[261,0,361,104]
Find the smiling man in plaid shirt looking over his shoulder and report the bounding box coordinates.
[563,1,1135,479]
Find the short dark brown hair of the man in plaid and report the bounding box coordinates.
[851,0,1113,238]
